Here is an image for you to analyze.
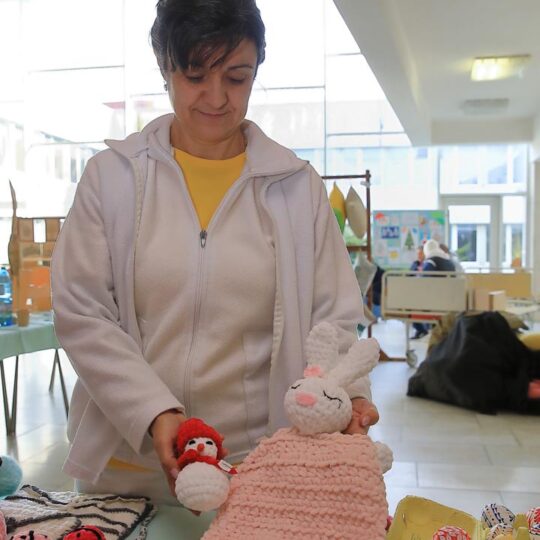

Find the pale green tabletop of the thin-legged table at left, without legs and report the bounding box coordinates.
[0,311,60,360]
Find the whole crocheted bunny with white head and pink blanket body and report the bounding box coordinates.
[203,323,392,540]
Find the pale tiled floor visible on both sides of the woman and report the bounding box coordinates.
[0,321,540,517]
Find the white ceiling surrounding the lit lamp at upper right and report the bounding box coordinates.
[334,0,540,146]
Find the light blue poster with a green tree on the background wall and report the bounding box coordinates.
[373,210,446,268]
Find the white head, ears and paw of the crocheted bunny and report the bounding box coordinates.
[285,322,392,472]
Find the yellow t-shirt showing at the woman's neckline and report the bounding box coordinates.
[174,148,246,230]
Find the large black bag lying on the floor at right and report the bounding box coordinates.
[407,311,540,414]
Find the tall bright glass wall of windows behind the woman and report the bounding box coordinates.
[0,0,527,264]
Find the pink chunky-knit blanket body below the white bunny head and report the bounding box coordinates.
[203,429,388,540]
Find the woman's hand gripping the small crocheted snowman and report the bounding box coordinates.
[148,409,187,498]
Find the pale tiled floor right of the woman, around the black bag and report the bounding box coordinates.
[370,321,540,517]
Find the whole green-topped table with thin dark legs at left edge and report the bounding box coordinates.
[0,311,65,435]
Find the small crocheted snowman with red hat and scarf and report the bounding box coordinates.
[175,418,236,512]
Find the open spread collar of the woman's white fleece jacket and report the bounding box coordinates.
[105,113,307,180]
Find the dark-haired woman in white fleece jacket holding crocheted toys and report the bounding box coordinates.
[52,0,378,503]
